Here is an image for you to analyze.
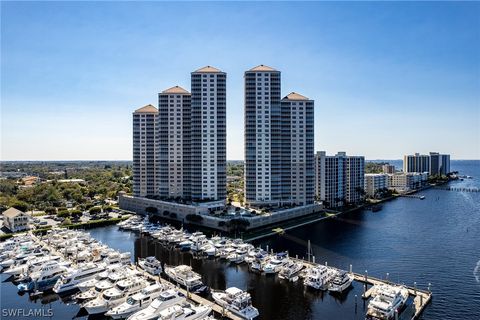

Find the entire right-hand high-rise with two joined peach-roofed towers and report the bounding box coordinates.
[245,65,314,207]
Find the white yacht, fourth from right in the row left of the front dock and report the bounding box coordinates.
[83,277,148,314]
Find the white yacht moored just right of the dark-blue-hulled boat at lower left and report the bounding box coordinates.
[53,263,105,293]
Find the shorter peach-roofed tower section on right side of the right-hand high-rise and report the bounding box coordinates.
[282,92,315,205]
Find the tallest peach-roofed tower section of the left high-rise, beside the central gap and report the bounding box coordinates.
[190,66,227,200]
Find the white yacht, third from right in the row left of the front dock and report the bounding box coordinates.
[105,283,165,319]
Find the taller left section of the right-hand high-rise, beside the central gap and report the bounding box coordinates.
[245,65,282,205]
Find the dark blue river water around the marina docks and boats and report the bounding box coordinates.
[0,161,480,320]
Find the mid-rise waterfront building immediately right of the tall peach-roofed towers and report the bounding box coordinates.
[315,151,365,208]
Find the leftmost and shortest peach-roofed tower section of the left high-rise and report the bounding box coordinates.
[133,105,158,197]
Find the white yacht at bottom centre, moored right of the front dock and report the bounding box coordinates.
[212,287,259,319]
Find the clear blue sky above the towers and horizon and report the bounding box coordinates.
[1,2,480,160]
